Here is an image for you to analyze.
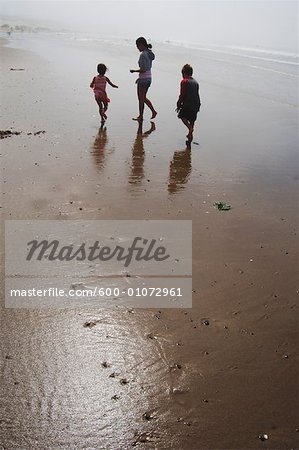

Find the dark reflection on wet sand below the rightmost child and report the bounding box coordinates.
[168,146,192,194]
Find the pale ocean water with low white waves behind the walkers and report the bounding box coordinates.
[3,32,299,106]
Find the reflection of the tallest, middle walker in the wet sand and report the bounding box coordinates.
[129,122,156,184]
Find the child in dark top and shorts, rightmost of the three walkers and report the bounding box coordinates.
[176,64,201,145]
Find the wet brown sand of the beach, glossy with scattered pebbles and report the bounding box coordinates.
[0,37,299,450]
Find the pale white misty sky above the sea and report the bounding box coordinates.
[0,0,299,52]
